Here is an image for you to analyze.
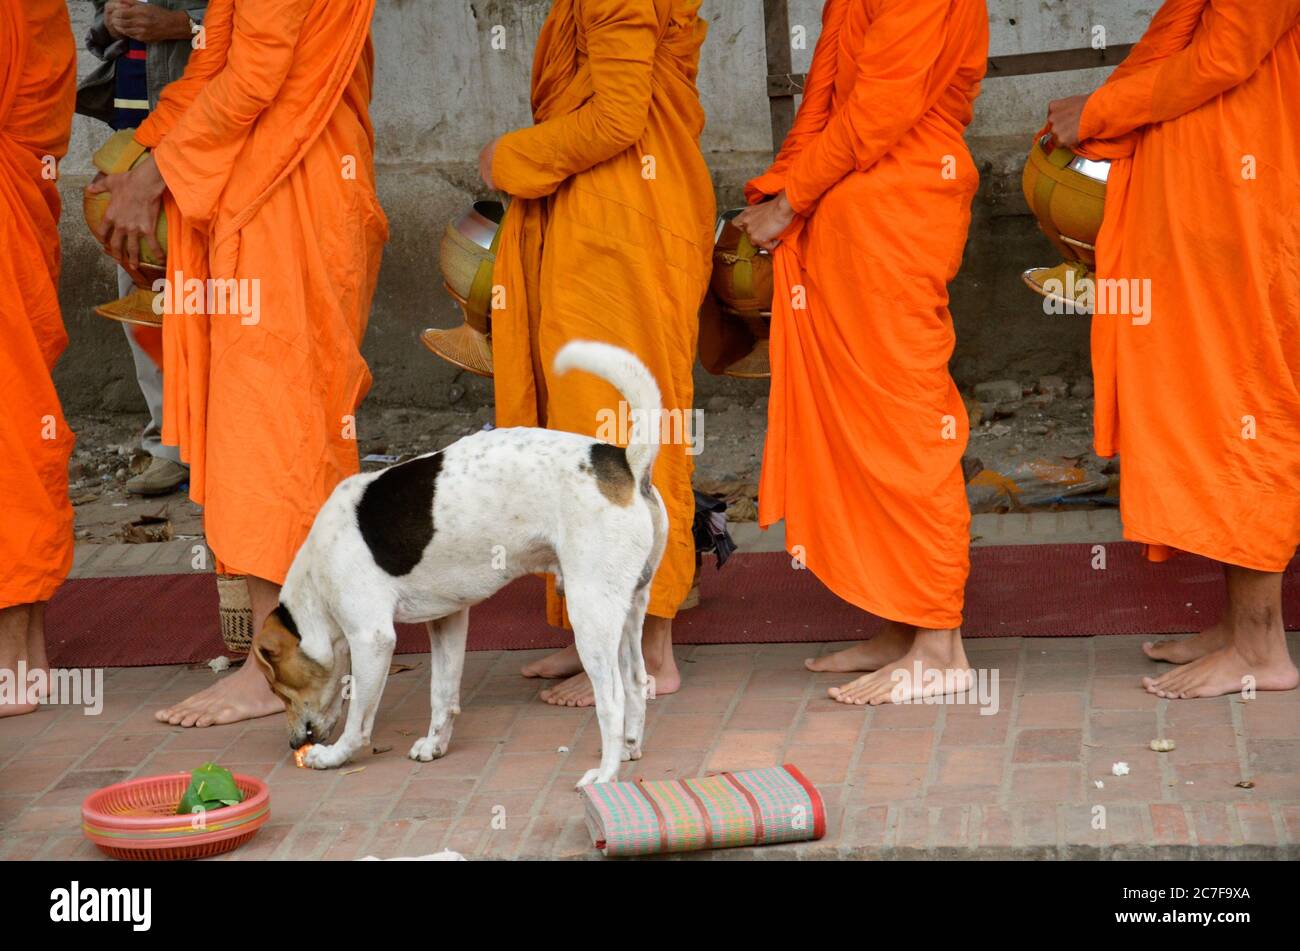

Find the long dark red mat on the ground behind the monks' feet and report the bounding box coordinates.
[46,543,1300,666]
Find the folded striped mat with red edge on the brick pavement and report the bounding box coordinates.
[582,764,826,856]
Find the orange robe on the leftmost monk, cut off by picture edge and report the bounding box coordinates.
[0,0,77,608]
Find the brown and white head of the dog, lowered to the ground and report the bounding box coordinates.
[252,604,345,750]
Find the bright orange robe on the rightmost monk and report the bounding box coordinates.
[1079,0,1300,572]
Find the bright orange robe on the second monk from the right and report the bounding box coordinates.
[746,0,988,629]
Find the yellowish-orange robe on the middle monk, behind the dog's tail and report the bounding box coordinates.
[493,0,715,625]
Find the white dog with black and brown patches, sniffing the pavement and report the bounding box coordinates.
[254,342,668,786]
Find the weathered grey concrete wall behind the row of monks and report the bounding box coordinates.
[56,0,1158,412]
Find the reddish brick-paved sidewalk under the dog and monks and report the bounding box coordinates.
[0,635,1300,860]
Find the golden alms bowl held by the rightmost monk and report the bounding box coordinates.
[1021,133,1110,272]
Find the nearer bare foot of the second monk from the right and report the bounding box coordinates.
[827,629,975,705]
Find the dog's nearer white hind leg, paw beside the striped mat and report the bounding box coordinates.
[566,574,631,786]
